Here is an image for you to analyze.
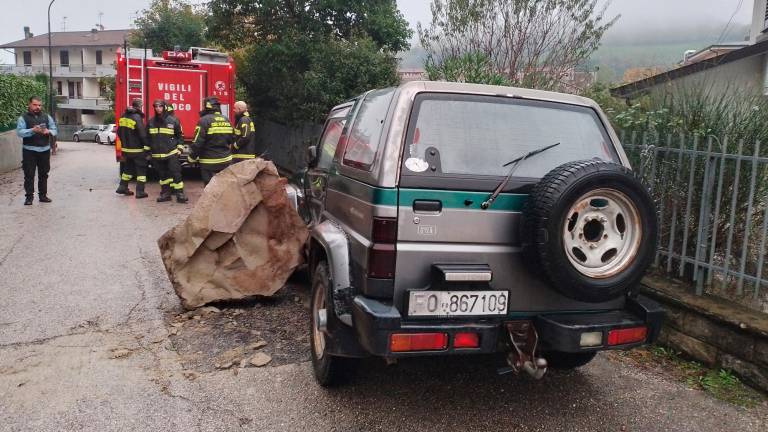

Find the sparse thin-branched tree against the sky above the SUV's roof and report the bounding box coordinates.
[418,0,618,89]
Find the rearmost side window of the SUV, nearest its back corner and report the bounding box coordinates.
[344,88,395,171]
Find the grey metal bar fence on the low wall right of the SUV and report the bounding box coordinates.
[623,134,768,313]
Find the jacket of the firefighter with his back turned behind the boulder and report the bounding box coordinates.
[189,110,234,165]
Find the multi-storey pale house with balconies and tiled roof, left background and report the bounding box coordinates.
[0,27,129,125]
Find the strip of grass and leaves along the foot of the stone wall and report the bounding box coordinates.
[613,345,768,409]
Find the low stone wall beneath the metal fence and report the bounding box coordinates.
[643,276,768,391]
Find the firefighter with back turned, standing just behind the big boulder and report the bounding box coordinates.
[189,96,234,185]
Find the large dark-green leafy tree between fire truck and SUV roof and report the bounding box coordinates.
[206,0,412,123]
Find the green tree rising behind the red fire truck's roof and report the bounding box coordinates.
[130,0,205,52]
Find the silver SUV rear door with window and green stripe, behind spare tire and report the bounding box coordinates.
[395,93,620,316]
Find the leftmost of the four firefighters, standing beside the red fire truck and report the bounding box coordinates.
[115,99,149,199]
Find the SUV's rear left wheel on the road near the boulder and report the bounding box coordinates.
[309,261,356,387]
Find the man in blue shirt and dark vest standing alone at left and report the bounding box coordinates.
[16,96,58,205]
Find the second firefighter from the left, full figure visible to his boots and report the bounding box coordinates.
[147,99,188,203]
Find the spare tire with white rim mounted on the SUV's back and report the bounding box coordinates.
[521,159,658,303]
